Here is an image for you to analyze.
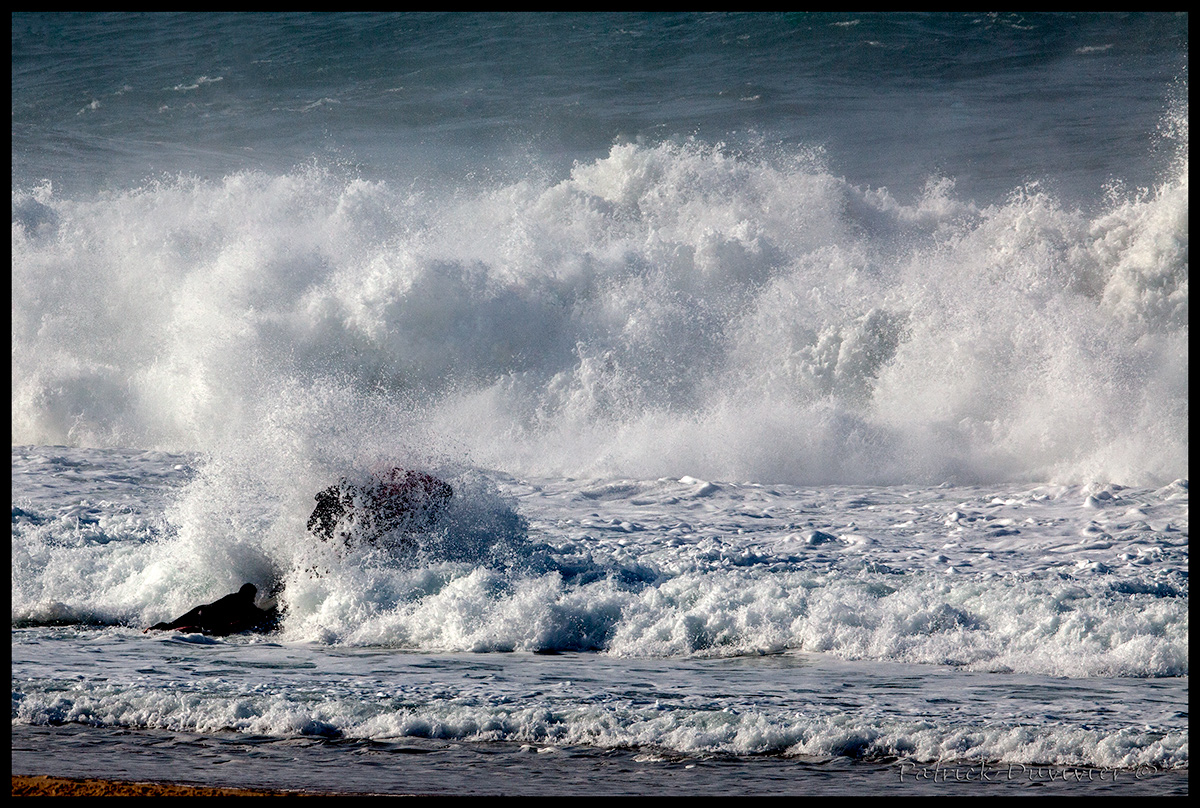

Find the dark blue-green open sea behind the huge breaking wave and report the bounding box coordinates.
[12,13,1188,200]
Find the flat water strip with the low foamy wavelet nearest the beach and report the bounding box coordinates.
[13,639,1188,768]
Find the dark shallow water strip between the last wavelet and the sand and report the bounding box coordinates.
[12,725,1188,796]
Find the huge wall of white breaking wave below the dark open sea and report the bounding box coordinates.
[12,132,1188,484]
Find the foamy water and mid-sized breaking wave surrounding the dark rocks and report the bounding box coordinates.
[12,448,1188,677]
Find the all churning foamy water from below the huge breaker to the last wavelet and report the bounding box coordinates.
[12,447,1188,773]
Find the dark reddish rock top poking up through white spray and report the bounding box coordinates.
[308,468,454,544]
